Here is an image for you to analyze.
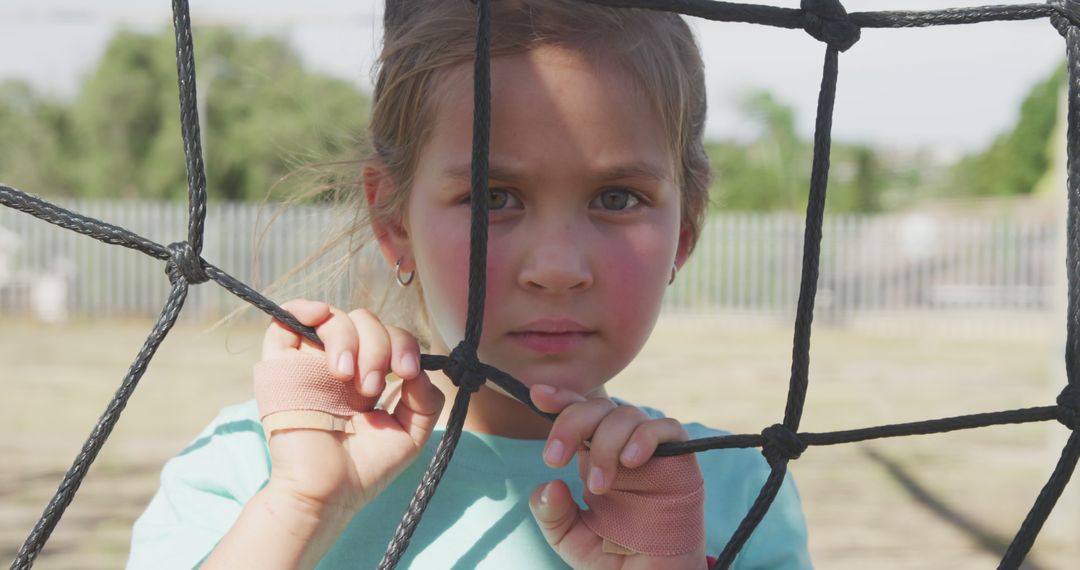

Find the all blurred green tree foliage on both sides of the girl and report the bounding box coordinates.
[0,28,1065,213]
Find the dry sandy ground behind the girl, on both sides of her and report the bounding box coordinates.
[0,316,1080,570]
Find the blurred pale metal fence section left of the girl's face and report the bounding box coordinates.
[0,201,356,321]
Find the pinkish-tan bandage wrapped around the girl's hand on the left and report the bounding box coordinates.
[255,354,378,434]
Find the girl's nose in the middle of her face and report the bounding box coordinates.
[518,230,593,293]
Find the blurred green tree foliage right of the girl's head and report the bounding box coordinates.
[707,61,1065,213]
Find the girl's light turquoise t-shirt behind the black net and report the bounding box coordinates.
[127,401,811,570]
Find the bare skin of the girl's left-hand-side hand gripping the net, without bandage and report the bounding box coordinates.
[262,299,444,518]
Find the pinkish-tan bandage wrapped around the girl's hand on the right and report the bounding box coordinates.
[578,450,705,556]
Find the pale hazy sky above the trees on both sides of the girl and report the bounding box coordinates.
[0,0,1065,149]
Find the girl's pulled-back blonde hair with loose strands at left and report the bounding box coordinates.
[243,0,711,339]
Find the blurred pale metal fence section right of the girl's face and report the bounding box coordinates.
[667,214,1059,317]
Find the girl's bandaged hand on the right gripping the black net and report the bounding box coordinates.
[529,385,706,570]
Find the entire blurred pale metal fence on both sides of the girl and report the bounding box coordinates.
[0,201,1061,326]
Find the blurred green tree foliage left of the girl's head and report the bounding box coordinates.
[0,28,368,204]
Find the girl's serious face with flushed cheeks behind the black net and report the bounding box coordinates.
[383,48,689,401]
